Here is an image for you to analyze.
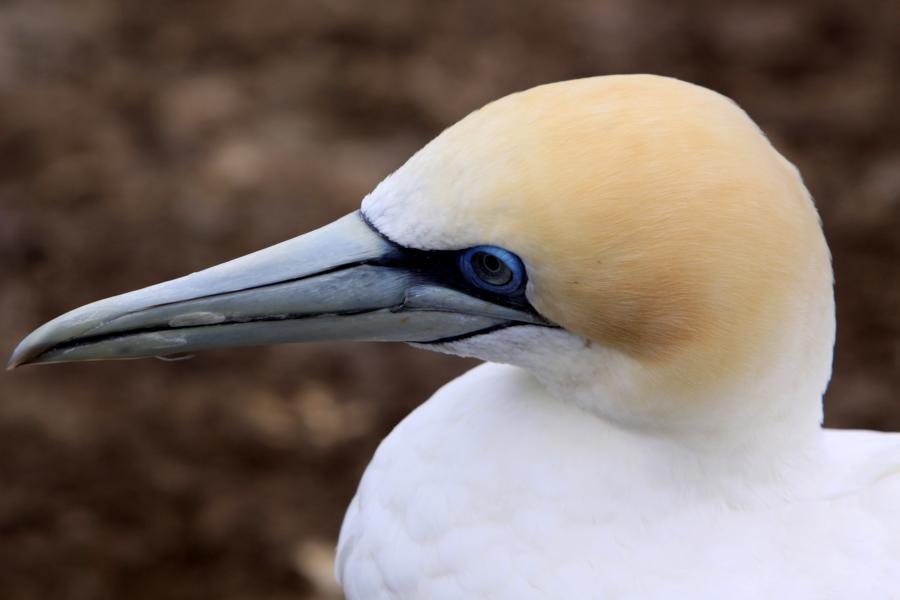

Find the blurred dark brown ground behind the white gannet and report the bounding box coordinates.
[0,0,900,600]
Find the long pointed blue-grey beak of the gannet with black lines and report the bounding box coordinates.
[8,212,549,369]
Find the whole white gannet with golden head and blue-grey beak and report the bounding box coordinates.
[9,74,900,600]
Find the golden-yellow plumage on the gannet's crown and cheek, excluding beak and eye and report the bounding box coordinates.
[363,75,831,390]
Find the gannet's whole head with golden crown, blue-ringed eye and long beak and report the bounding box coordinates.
[10,75,834,432]
